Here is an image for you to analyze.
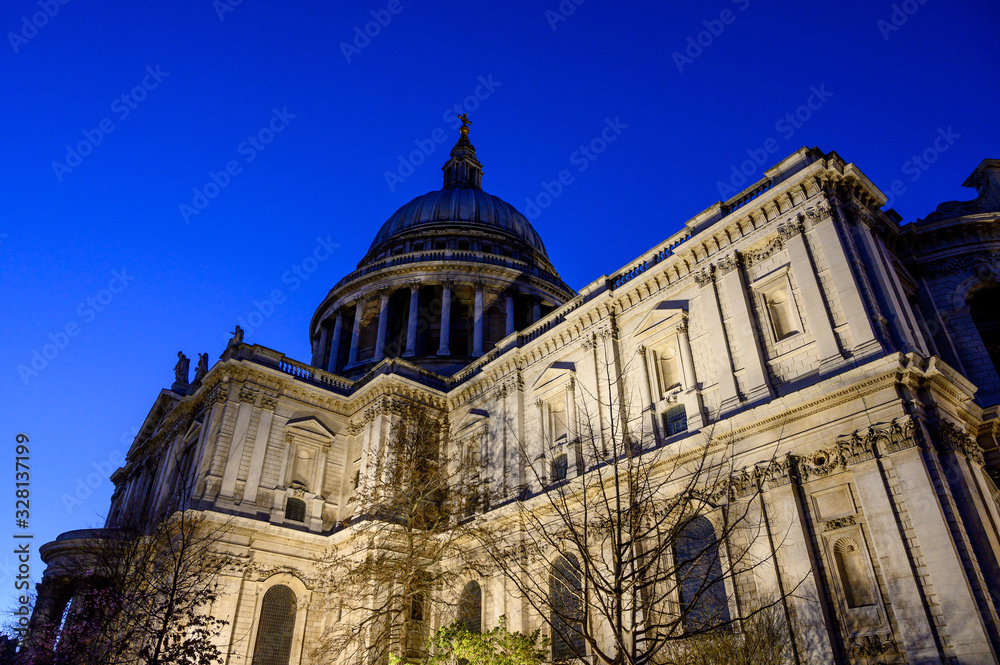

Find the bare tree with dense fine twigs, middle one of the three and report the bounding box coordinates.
[314,405,478,664]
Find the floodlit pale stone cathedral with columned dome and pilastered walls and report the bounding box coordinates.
[29,122,1000,665]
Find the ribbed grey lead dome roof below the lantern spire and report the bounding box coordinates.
[368,187,545,254]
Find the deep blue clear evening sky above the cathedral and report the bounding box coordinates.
[0,0,1000,594]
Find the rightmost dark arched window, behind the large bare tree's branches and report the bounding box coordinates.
[674,515,730,631]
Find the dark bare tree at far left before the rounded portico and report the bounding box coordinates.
[26,474,228,665]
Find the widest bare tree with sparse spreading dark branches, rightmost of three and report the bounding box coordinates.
[474,326,791,665]
